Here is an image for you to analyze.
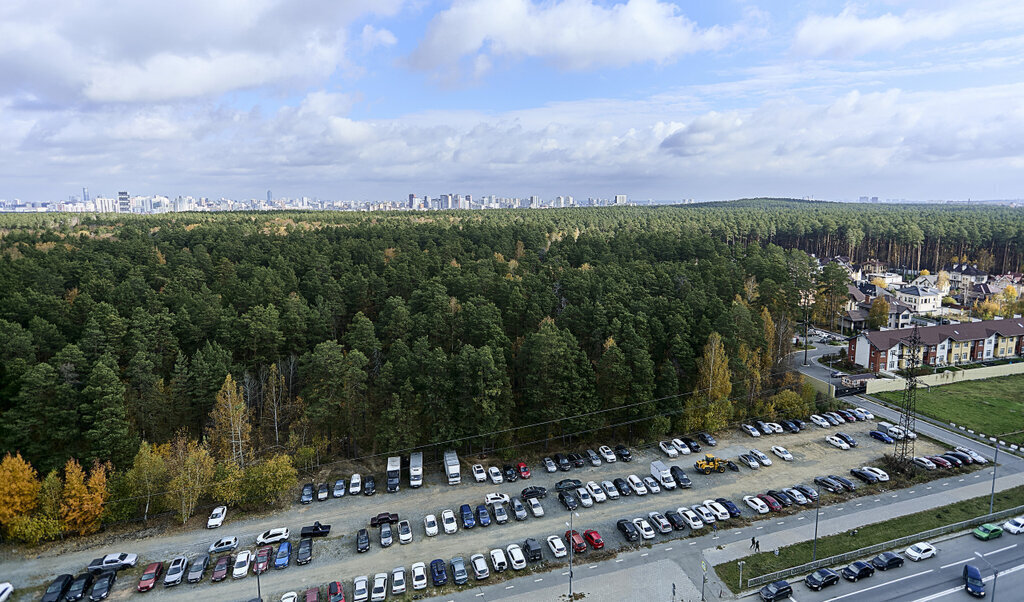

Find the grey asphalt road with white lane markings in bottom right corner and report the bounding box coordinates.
[791,534,1024,602]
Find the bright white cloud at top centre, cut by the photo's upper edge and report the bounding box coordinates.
[411,0,742,74]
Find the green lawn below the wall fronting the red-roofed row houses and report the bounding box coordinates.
[877,376,1024,443]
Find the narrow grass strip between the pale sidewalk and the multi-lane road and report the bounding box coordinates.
[715,487,1024,592]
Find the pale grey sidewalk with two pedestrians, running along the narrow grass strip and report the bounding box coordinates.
[703,471,1024,566]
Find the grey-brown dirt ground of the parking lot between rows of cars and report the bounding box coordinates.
[4,422,941,600]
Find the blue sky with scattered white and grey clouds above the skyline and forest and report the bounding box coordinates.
[0,0,1024,201]
